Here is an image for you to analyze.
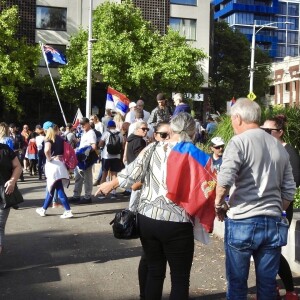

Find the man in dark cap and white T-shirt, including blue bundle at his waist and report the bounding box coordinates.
[70,118,98,204]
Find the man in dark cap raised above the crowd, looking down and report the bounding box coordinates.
[148,93,172,126]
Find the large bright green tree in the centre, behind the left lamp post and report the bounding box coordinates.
[61,1,205,103]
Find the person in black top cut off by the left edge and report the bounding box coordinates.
[0,143,22,254]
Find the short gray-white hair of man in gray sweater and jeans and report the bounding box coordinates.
[230,98,261,124]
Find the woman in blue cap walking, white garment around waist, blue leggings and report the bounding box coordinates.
[36,121,73,219]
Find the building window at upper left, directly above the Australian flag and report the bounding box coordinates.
[36,6,67,31]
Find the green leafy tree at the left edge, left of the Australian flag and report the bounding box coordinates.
[0,6,40,117]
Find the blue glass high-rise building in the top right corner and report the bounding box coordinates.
[212,0,300,61]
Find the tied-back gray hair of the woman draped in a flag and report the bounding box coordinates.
[170,112,196,142]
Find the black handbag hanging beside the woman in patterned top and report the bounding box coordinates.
[109,209,140,240]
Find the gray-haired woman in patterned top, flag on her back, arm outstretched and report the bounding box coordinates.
[96,113,214,300]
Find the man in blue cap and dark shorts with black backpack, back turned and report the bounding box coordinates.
[99,121,123,198]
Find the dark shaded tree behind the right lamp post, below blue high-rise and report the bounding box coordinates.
[210,22,270,110]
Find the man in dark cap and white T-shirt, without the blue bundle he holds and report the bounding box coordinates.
[70,118,96,204]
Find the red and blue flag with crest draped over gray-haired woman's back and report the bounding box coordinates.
[166,142,216,232]
